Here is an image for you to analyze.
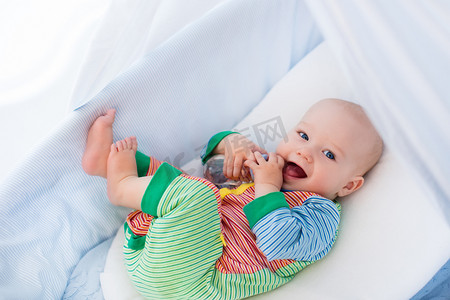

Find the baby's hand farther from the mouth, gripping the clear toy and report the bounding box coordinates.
[218,134,267,181]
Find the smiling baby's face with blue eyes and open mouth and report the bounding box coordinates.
[276,99,367,199]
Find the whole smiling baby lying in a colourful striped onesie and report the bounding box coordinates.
[82,99,383,299]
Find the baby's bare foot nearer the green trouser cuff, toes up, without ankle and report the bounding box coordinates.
[106,136,138,205]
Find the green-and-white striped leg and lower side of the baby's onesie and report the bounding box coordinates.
[124,176,307,299]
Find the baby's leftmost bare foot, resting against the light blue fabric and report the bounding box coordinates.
[81,109,116,178]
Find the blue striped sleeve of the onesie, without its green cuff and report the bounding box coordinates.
[252,197,339,261]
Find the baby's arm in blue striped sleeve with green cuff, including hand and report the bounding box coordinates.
[244,152,339,261]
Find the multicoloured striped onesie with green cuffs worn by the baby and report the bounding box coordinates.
[124,134,340,299]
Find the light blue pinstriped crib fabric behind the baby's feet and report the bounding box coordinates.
[0,0,321,299]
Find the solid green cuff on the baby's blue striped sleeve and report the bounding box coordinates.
[244,192,289,228]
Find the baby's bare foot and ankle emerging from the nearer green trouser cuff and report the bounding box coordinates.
[106,137,152,210]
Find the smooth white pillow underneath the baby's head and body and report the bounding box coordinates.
[101,43,450,299]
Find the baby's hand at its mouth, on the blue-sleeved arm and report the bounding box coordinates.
[244,152,284,197]
